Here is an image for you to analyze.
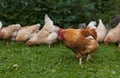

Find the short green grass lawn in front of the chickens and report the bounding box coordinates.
[0,41,120,78]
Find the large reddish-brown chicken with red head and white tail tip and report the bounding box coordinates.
[57,21,98,64]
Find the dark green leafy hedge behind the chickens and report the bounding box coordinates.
[0,0,120,28]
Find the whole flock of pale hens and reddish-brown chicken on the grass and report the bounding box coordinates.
[0,15,120,64]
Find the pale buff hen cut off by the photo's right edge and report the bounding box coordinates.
[104,23,120,50]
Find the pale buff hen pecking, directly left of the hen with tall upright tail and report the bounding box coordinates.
[16,24,40,42]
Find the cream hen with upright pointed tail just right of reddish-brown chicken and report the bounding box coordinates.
[96,19,107,42]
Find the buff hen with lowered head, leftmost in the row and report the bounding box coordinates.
[0,24,21,40]
